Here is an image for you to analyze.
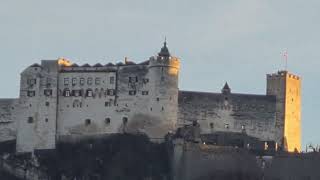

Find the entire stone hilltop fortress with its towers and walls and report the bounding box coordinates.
[0,42,301,152]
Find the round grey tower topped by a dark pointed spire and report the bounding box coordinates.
[148,42,180,138]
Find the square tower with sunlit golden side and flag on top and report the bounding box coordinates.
[267,71,301,152]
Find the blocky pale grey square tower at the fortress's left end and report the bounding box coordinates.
[17,60,58,152]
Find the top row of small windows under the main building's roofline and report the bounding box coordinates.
[63,76,115,86]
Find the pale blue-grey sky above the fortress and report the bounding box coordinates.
[0,0,320,146]
